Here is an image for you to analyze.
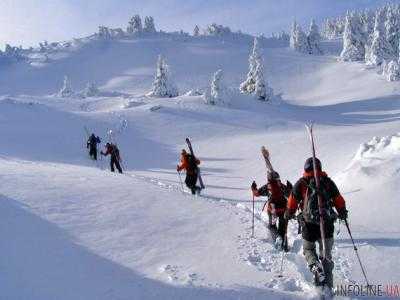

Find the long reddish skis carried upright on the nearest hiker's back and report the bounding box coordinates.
[306,123,326,260]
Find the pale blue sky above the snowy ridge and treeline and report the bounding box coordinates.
[0,0,400,49]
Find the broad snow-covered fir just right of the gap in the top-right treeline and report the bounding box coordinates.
[340,12,365,61]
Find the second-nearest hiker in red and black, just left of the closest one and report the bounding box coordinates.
[251,171,290,251]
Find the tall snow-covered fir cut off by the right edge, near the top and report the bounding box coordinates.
[385,6,400,57]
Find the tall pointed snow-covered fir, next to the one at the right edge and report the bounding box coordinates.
[365,9,391,66]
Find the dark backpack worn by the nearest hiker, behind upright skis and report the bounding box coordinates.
[302,177,336,224]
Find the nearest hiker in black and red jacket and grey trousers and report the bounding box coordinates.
[285,157,347,289]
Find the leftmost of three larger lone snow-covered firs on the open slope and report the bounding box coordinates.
[148,55,178,98]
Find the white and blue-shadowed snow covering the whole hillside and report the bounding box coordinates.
[0,26,400,299]
